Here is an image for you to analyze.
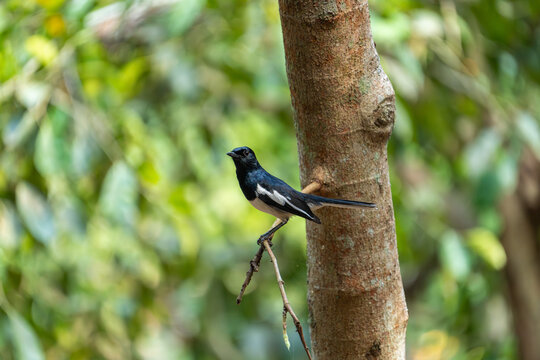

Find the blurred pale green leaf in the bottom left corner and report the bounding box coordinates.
[6,310,45,360]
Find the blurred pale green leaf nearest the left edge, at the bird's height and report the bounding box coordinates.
[15,183,56,245]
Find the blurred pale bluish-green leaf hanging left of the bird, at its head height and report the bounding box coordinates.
[99,162,138,227]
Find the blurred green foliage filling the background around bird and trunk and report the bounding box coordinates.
[0,0,540,360]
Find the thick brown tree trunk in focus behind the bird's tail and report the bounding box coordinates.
[279,0,408,360]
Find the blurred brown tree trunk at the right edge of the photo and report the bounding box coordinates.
[501,151,540,360]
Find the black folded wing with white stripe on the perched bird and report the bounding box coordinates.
[255,172,321,224]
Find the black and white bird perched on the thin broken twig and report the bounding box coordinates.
[227,146,375,242]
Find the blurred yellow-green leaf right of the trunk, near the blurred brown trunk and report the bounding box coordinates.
[467,228,506,270]
